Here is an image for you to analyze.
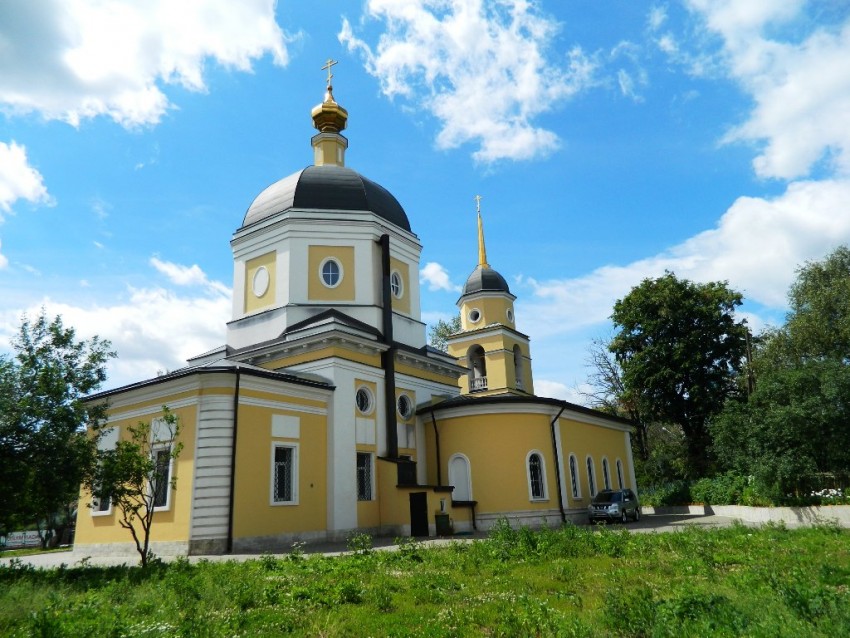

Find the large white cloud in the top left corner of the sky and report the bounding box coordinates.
[0,0,287,127]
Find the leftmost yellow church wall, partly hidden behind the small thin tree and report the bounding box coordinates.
[74,404,198,545]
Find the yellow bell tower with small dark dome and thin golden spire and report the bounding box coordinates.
[447,200,534,396]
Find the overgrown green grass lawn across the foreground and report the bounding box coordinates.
[0,525,850,638]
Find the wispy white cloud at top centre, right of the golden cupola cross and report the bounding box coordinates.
[339,0,595,162]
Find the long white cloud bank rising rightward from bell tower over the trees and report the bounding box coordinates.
[518,180,850,338]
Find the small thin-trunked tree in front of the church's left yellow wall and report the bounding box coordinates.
[84,406,183,567]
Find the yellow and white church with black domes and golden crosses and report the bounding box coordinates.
[75,70,637,555]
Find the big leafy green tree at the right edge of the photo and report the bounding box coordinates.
[711,246,850,499]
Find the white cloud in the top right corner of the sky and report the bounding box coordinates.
[690,0,850,179]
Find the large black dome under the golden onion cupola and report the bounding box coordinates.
[242,165,410,232]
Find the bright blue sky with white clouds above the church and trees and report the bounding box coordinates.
[0,0,850,402]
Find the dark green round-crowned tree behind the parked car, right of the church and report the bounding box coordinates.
[610,272,747,478]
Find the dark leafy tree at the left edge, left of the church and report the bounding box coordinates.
[0,309,115,546]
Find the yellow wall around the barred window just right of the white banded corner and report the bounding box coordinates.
[233,392,327,538]
